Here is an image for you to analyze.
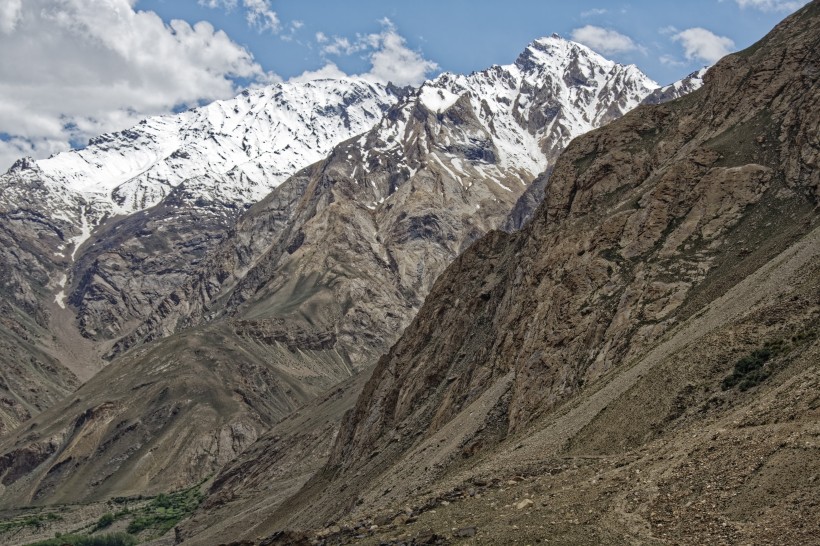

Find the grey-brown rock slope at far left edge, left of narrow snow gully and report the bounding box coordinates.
[0,162,78,435]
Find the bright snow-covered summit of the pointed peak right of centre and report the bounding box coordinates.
[410,35,659,179]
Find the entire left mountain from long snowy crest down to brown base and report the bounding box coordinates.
[0,80,402,434]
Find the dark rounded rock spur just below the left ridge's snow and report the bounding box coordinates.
[68,176,246,342]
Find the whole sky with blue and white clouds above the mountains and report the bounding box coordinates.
[0,0,807,170]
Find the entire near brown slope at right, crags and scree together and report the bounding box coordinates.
[175,1,820,544]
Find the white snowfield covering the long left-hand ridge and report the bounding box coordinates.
[37,78,396,214]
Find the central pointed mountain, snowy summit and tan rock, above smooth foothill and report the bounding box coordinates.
[110,38,656,356]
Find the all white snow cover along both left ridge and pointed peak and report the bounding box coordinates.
[0,35,699,262]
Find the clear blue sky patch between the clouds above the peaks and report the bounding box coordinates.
[137,0,798,83]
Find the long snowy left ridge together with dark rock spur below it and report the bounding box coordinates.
[0,79,402,341]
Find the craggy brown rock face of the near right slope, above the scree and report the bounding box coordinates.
[264,2,820,525]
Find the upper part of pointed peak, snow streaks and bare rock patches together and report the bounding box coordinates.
[330,35,659,219]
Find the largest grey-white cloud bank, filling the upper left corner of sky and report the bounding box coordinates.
[0,0,277,170]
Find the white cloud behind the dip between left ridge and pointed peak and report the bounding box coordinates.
[310,19,438,85]
